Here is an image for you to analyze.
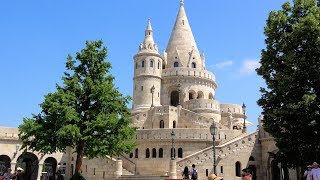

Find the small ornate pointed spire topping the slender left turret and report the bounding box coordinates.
[139,18,159,54]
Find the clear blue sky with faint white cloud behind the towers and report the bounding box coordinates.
[0,0,285,131]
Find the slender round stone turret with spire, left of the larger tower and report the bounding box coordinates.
[132,19,163,114]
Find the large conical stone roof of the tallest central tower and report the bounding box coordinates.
[166,0,200,66]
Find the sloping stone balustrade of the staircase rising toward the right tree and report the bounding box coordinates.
[177,132,258,171]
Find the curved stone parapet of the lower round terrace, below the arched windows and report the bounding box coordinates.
[182,99,220,112]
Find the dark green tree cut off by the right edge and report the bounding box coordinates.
[257,0,320,167]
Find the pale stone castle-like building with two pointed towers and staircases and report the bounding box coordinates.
[0,1,295,180]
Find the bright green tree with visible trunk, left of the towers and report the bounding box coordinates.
[19,41,135,179]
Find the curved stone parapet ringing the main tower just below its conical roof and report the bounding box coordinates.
[162,67,216,82]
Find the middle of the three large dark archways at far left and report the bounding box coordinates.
[16,152,39,180]
